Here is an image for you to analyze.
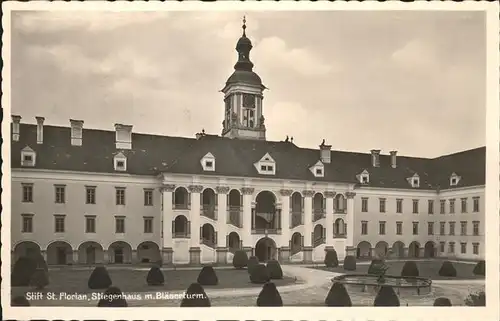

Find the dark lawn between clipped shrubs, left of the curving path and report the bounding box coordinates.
[12,268,296,295]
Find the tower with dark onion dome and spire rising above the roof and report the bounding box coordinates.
[221,17,267,140]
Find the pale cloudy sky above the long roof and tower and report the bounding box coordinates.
[12,11,486,157]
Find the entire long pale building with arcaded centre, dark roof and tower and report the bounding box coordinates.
[11,20,485,264]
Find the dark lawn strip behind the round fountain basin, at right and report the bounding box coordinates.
[311,260,484,280]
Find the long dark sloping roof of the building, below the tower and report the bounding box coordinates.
[11,124,486,189]
